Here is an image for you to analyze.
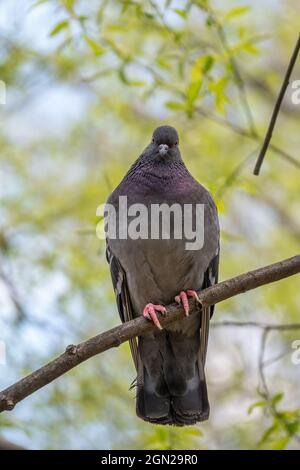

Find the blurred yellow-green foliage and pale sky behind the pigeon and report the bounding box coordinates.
[0,0,300,449]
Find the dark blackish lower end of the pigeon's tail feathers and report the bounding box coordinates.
[136,365,209,426]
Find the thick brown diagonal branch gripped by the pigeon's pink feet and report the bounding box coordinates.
[0,255,300,412]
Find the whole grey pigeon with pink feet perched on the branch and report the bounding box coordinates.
[107,126,219,426]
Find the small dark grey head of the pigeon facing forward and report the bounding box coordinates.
[151,126,181,160]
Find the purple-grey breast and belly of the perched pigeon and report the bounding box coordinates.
[108,162,219,324]
